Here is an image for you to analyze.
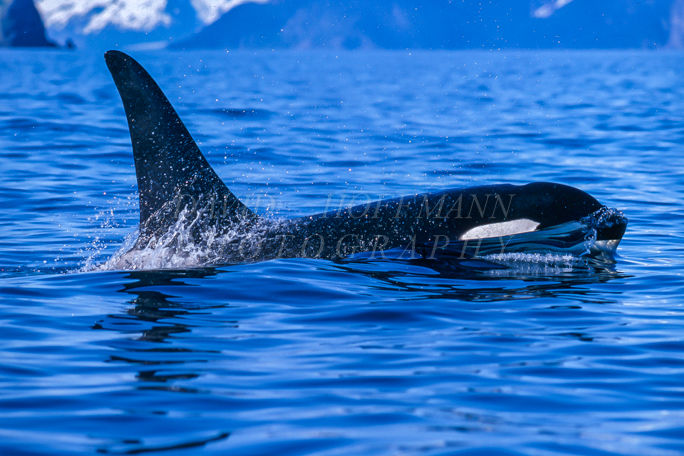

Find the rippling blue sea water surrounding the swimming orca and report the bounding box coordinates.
[0,50,684,456]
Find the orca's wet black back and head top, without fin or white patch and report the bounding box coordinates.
[255,182,602,259]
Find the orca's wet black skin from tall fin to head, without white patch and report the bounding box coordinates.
[105,51,625,262]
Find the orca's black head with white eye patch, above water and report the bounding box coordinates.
[459,182,627,258]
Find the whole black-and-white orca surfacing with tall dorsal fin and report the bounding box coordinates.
[105,51,627,269]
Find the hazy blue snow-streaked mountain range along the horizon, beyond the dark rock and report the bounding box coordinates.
[20,0,684,49]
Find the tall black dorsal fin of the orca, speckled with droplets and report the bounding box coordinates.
[105,51,255,239]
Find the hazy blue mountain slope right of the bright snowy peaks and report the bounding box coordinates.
[173,0,673,49]
